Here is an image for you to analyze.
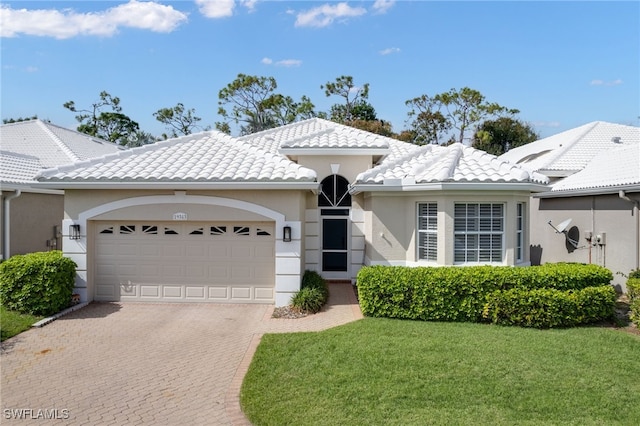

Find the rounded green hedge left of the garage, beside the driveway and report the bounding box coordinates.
[0,251,77,315]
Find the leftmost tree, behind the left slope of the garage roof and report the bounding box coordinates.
[62,91,140,146]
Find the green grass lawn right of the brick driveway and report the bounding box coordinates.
[241,318,640,426]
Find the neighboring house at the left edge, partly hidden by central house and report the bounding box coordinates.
[0,120,121,259]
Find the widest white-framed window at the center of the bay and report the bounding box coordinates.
[453,202,506,264]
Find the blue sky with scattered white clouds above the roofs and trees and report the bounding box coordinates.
[0,0,640,137]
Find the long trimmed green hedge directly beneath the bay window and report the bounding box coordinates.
[357,263,613,330]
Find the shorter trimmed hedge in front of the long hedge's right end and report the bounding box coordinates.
[483,286,616,328]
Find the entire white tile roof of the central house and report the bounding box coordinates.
[32,118,548,189]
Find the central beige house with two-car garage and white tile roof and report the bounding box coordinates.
[38,119,548,306]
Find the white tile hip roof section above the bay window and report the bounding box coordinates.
[356,143,548,184]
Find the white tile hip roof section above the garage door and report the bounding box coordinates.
[39,132,316,182]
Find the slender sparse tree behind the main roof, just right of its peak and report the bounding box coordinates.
[320,75,376,124]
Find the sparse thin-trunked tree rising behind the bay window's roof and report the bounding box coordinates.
[406,87,519,143]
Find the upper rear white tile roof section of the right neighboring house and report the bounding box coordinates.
[500,121,640,176]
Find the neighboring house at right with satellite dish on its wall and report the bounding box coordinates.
[500,121,640,291]
